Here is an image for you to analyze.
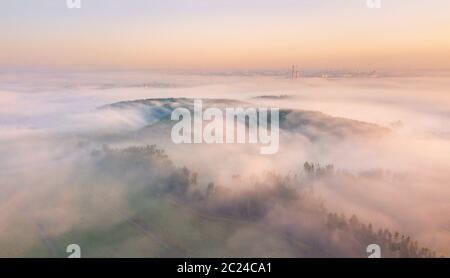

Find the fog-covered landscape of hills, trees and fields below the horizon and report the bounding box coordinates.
[0,71,450,257]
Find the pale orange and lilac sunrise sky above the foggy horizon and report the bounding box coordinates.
[0,0,450,70]
